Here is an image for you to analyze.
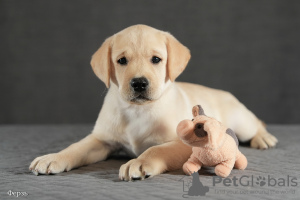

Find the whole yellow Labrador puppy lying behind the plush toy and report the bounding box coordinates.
[29,25,277,181]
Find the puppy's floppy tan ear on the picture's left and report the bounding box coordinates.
[91,37,112,88]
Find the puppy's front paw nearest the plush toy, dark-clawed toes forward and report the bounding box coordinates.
[119,158,162,181]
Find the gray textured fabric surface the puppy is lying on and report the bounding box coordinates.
[0,125,300,200]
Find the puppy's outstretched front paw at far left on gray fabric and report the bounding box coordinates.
[29,153,68,175]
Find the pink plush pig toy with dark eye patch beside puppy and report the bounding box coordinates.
[177,105,247,177]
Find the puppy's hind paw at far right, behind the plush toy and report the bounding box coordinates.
[251,132,278,149]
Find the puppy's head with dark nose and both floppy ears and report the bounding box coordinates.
[91,25,190,104]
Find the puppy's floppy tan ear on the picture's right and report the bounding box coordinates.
[166,33,191,82]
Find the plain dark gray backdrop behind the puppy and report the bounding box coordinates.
[0,0,300,123]
